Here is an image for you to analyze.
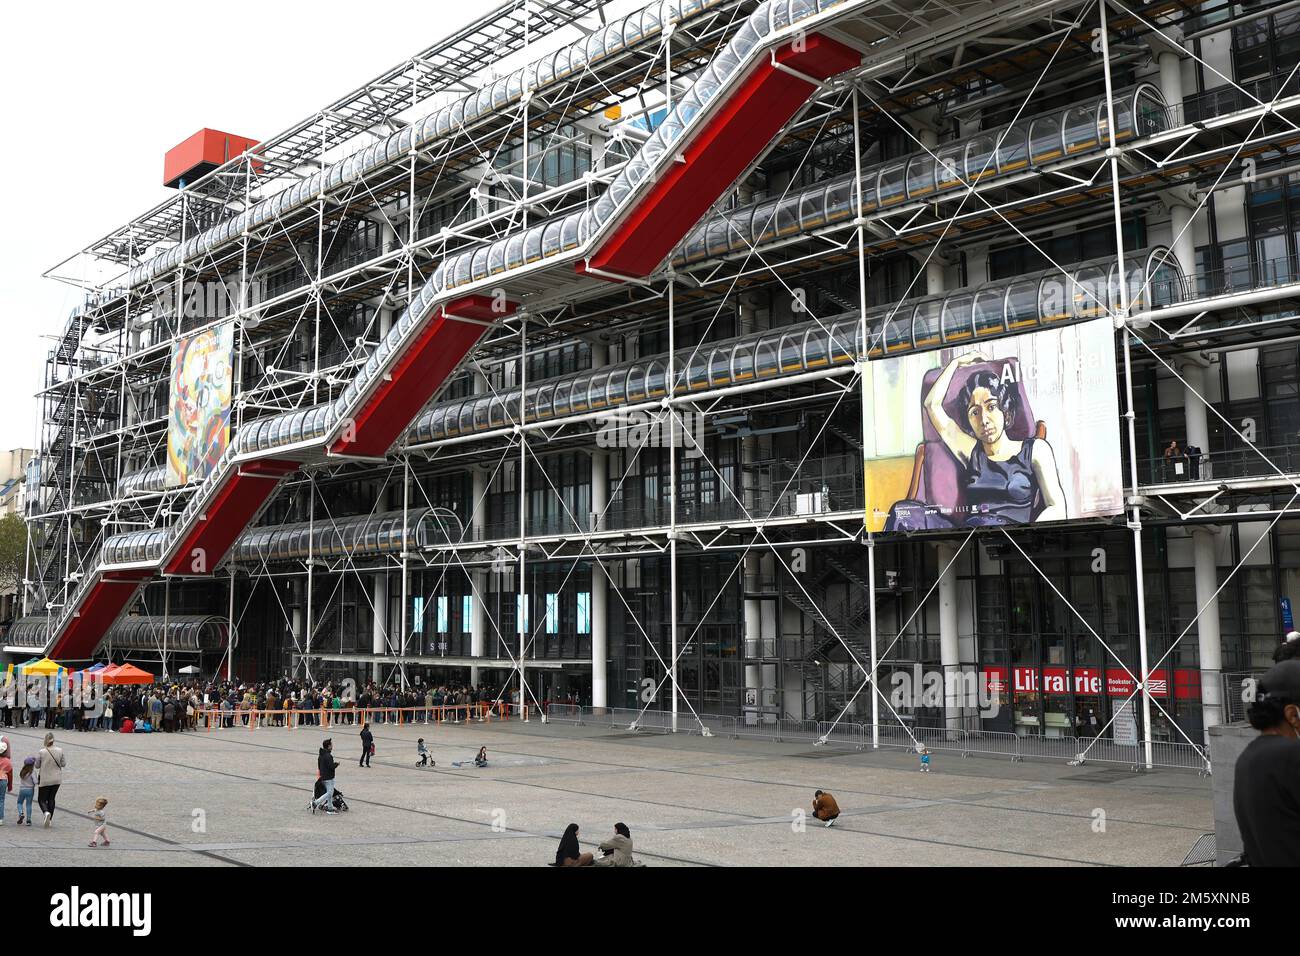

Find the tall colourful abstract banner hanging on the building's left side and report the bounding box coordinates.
[166,323,234,488]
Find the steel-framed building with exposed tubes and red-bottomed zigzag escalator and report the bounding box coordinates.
[15,0,1300,763]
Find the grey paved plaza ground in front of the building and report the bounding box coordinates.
[0,722,1213,866]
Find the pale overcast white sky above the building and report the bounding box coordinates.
[0,0,495,449]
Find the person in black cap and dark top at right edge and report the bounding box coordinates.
[1232,661,1300,866]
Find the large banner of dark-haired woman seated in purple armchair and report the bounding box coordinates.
[863,319,1125,532]
